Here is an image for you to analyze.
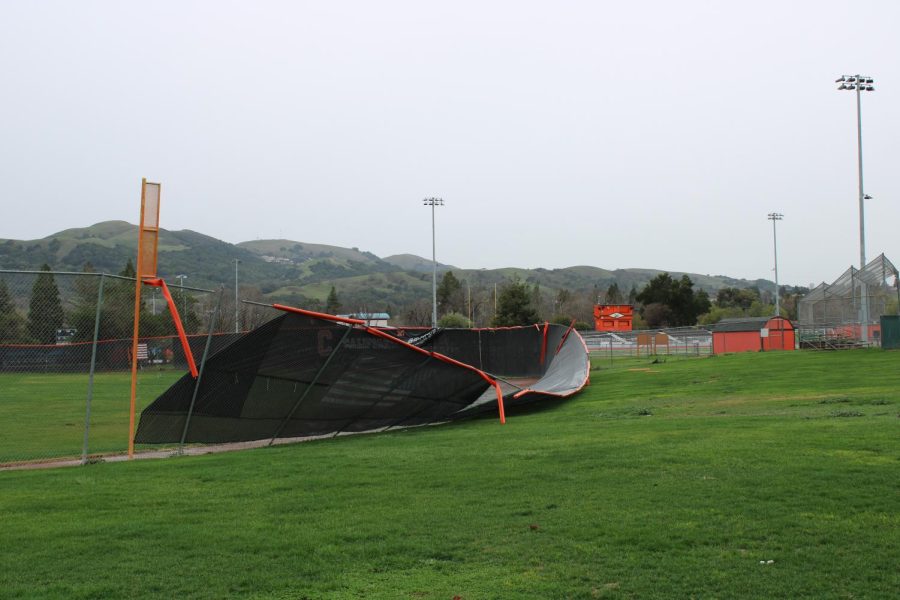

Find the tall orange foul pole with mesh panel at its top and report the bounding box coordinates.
[128,179,161,458]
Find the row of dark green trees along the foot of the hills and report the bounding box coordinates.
[0,260,802,344]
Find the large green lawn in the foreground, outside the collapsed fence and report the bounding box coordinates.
[0,351,900,600]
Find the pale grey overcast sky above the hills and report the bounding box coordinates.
[0,0,900,285]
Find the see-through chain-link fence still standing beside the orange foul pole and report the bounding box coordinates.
[0,270,272,467]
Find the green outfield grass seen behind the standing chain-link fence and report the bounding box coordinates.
[0,369,184,464]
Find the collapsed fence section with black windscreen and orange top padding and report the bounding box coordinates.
[135,307,589,444]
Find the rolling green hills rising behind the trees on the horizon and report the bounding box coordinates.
[0,221,772,310]
